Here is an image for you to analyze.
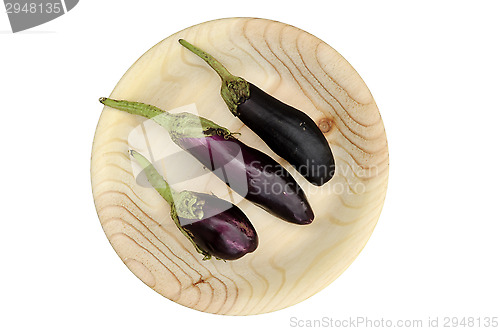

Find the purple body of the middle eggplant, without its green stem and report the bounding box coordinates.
[177,134,314,224]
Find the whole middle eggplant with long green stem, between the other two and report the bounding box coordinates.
[99,98,314,225]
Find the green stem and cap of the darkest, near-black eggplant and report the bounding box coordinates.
[179,39,250,116]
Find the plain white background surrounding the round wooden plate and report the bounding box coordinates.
[0,0,500,331]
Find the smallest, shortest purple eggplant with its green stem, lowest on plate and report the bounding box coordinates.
[129,151,258,260]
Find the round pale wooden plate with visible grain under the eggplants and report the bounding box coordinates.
[91,18,389,315]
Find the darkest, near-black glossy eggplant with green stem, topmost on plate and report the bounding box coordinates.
[179,39,335,186]
